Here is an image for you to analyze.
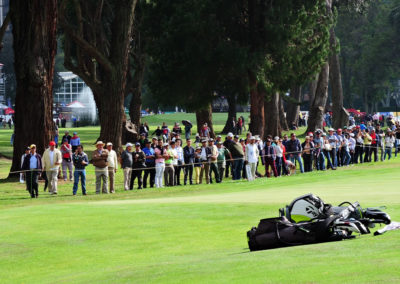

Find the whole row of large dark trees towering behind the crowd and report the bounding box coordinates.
[2,0,397,175]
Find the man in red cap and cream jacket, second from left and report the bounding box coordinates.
[42,141,62,194]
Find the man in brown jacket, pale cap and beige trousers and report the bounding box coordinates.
[92,141,108,194]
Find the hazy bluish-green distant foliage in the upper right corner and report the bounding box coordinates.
[336,0,400,109]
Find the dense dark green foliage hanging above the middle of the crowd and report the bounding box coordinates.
[146,0,333,110]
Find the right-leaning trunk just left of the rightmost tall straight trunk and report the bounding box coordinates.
[306,63,329,133]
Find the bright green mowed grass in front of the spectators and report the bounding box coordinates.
[0,112,400,283]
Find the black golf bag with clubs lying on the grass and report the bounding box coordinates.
[247,194,390,251]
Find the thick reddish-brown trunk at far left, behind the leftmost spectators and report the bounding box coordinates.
[9,0,57,177]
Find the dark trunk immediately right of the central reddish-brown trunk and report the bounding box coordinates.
[264,93,282,139]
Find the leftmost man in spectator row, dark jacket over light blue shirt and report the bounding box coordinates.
[22,144,43,198]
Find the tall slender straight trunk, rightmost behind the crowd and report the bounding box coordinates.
[329,28,349,129]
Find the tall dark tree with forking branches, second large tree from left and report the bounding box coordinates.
[60,0,137,148]
